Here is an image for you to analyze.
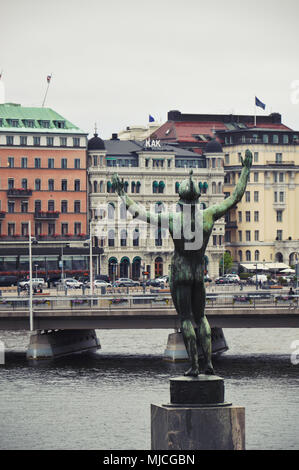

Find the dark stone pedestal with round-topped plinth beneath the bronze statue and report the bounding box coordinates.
[151,375,245,450]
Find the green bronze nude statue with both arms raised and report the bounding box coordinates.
[112,150,252,377]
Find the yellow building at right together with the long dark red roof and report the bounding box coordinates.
[151,111,299,264]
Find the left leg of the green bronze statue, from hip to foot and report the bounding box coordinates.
[171,284,199,377]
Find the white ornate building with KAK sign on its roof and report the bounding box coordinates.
[88,134,224,279]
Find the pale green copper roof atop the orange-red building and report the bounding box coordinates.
[0,103,87,134]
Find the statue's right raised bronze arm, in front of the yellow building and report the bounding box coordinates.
[206,149,252,220]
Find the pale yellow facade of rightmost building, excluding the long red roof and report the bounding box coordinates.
[217,120,299,264]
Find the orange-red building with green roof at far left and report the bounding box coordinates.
[0,103,97,271]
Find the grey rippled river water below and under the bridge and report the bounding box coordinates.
[0,329,299,450]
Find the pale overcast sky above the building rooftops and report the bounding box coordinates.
[0,0,299,138]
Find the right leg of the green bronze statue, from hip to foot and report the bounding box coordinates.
[192,281,214,375]
